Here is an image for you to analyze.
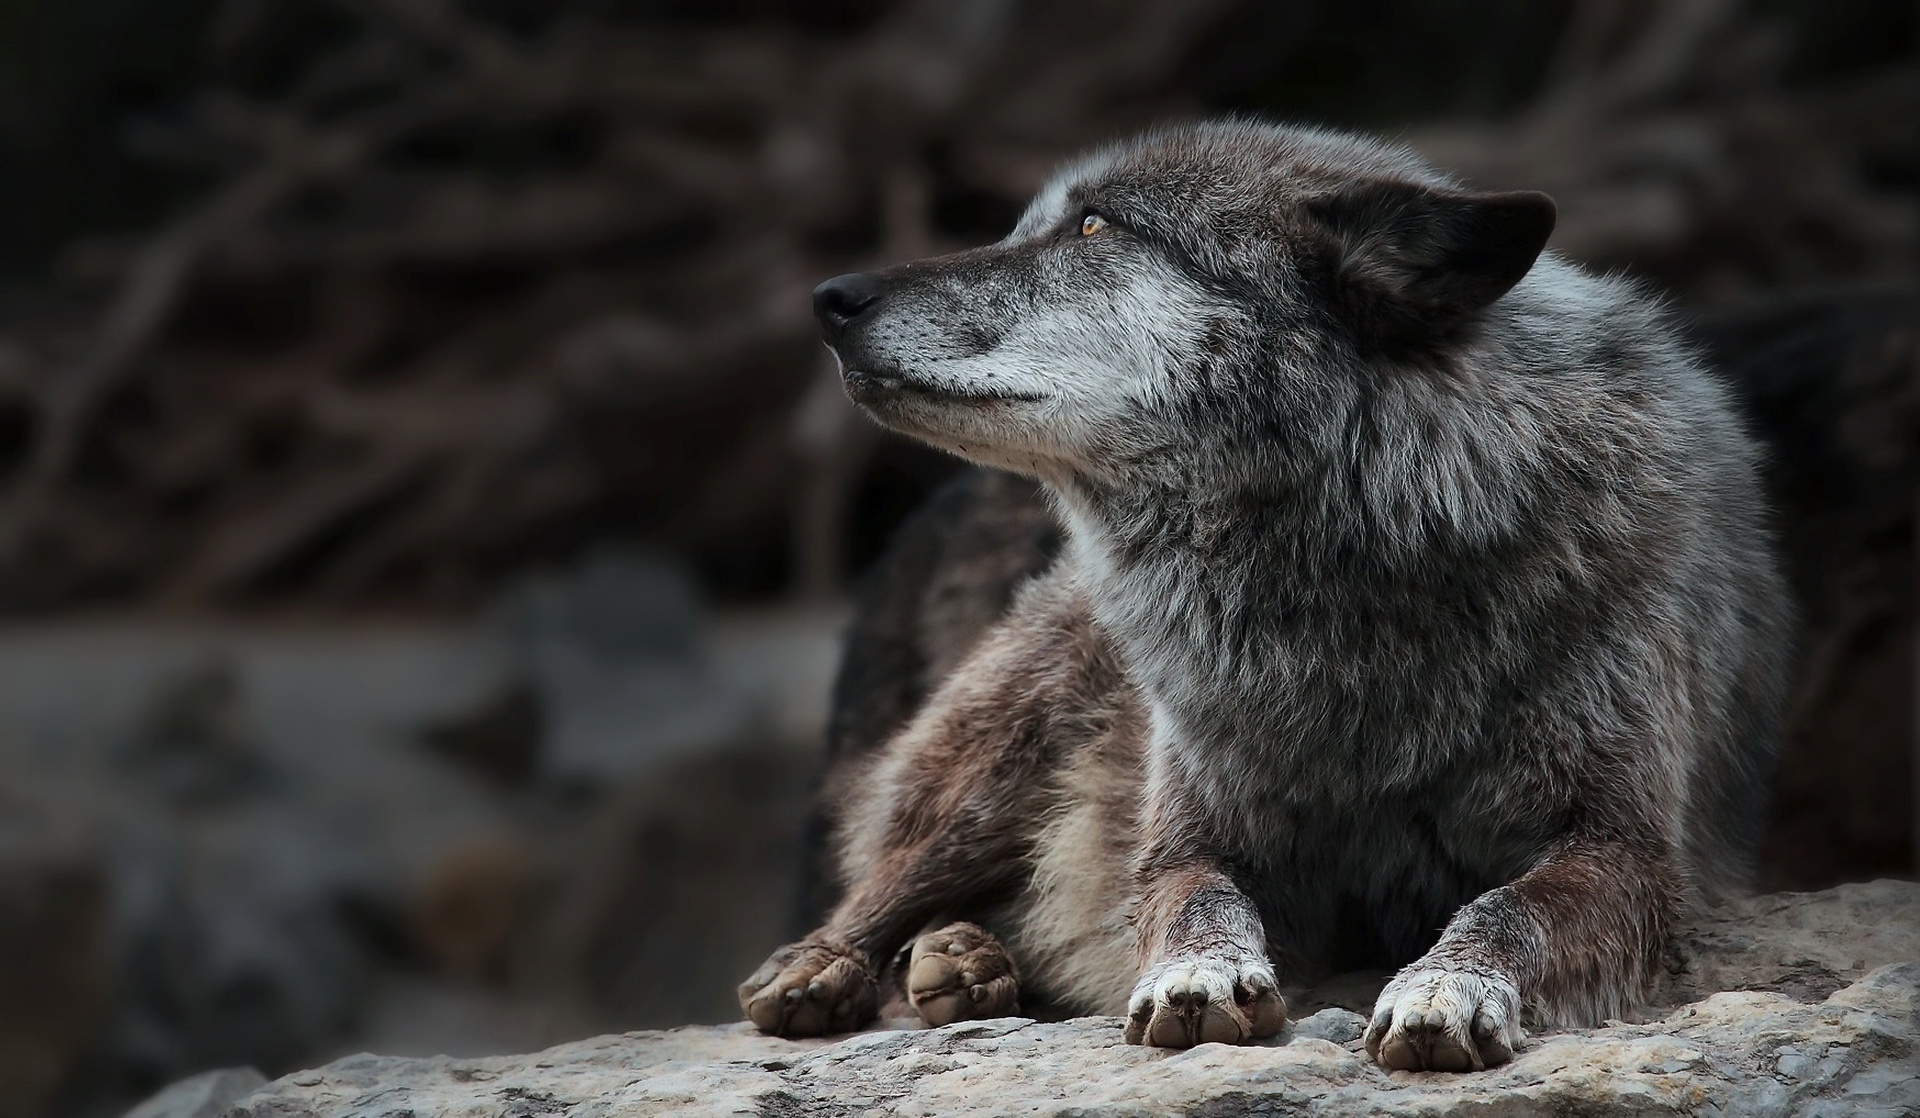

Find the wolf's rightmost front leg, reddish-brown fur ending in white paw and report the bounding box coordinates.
[1367,839,1678,1072]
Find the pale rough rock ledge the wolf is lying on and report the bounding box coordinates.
[183,882,1920,1118]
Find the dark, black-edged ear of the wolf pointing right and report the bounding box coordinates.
[1309,182,1553,340]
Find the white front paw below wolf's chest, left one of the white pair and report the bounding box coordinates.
[1127,955,1286,1049]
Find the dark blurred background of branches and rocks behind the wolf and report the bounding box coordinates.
[0,0,1920,1118]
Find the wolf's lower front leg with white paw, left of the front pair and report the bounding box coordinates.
[1125,859,1286,1049]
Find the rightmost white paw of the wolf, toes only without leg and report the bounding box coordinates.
[1367,964,1521,1072]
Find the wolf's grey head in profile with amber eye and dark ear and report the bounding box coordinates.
[814,123,1553,488]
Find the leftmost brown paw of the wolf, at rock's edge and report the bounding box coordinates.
[739,939,879,1037]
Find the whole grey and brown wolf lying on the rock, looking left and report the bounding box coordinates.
[739,121,1791,1070]
